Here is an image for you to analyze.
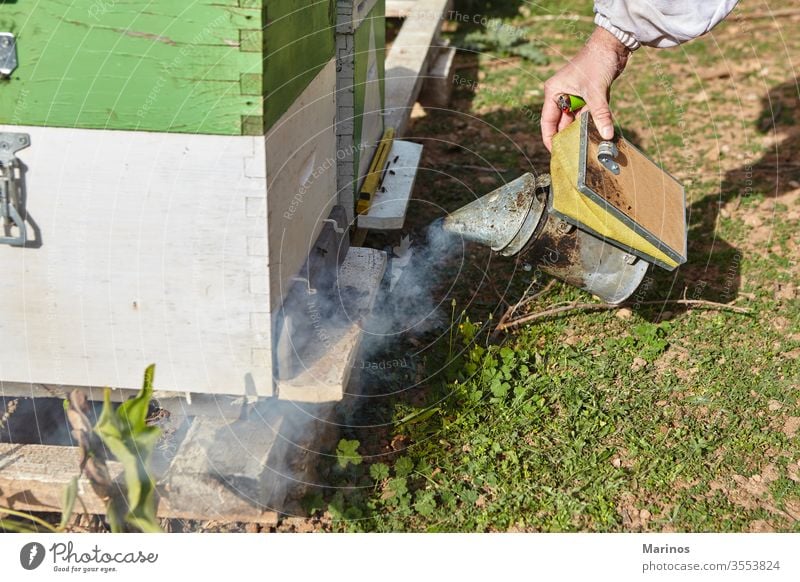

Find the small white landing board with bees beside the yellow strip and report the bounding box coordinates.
[358,140,422,230]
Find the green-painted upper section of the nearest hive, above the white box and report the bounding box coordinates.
[0,0,335,135]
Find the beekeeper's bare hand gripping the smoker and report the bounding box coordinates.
[541,27,631,151]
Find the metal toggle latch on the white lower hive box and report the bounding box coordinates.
[0,132,31,246]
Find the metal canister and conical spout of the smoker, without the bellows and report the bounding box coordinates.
[442,174,650,303]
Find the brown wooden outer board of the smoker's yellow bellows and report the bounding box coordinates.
[578,120,686,262]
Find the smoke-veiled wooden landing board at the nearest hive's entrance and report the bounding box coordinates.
[278,247,386,403]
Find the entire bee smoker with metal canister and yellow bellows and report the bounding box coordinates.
[443,116,686,303]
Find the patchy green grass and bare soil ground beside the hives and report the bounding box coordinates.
[307,1,800,532]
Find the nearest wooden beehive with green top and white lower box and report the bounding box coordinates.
[0,0,350,396]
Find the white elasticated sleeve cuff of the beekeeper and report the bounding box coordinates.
[594,0,738,50]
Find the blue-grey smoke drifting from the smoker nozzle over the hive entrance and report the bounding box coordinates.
[248,220,464,512]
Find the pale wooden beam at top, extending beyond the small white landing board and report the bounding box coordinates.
[386,0,451,136]
